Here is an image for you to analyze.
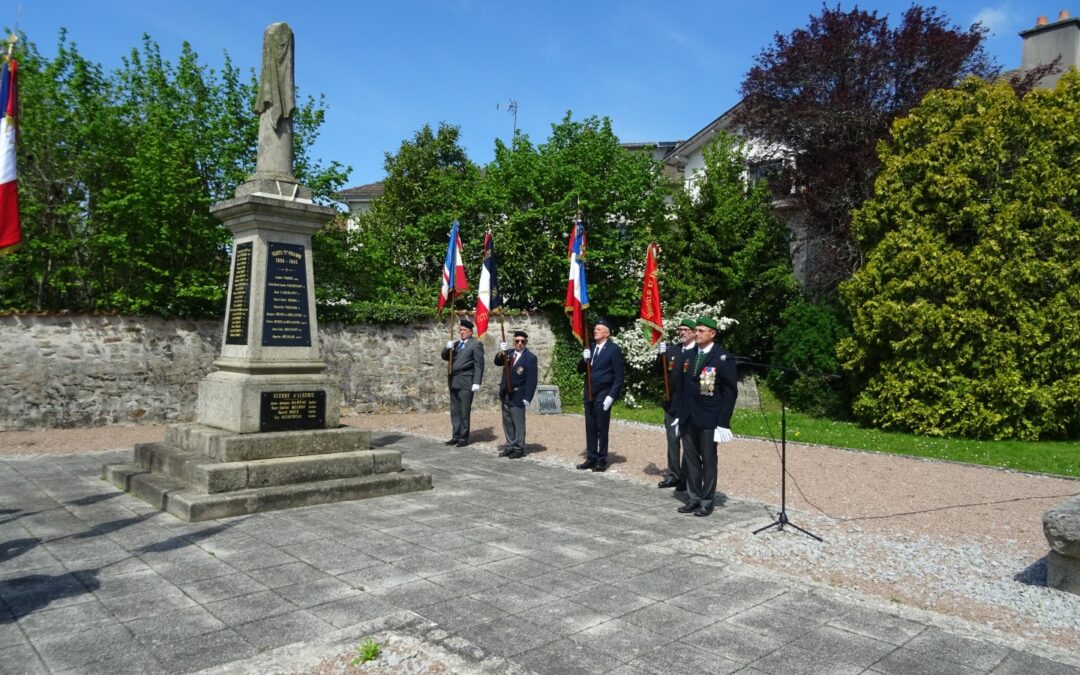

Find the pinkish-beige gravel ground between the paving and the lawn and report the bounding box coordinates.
[0,411,1080,656]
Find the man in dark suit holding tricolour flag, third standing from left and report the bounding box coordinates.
[578,319,622,471]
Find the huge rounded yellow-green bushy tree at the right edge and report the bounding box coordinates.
[839,71,1080,440]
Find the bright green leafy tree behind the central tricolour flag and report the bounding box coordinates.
[478,112,670,319]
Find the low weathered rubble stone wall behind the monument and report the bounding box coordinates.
[0,314,554,431]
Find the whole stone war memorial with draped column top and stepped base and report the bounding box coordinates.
[105,23,431,521]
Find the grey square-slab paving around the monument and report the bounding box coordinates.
[0,434,1080,674]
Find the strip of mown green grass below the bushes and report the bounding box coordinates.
[563,395,1080,477]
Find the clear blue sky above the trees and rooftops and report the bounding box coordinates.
[14,0,1054,186]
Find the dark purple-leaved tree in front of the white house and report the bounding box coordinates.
[738,4,997,292]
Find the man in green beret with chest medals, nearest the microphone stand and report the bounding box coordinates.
[677,316,739,516]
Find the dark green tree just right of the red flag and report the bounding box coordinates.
[663,134,797,360]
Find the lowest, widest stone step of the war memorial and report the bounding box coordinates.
[104,464,431,522]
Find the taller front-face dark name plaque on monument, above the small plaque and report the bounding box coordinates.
[262,242,311,347]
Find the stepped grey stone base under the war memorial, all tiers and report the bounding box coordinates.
[103,423,431,522]
